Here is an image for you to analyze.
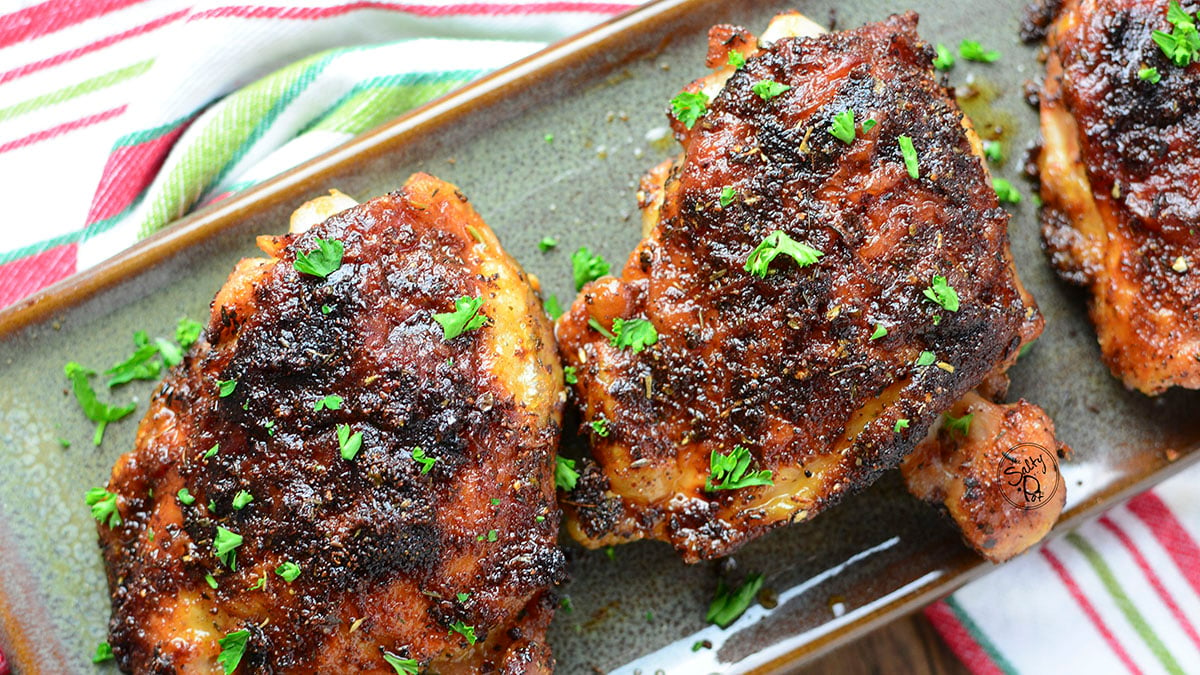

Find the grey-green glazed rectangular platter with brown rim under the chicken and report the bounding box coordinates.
[0,0,1200,674]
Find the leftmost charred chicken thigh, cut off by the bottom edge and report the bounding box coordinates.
[100,174,564,674]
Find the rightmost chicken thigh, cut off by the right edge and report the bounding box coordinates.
[1038,0,1200,395]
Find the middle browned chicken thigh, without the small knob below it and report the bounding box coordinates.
[556,13,1042,562]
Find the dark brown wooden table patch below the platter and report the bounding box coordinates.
[796,613,971,675]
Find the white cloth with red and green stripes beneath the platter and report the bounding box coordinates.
[0,0,1200,675]
